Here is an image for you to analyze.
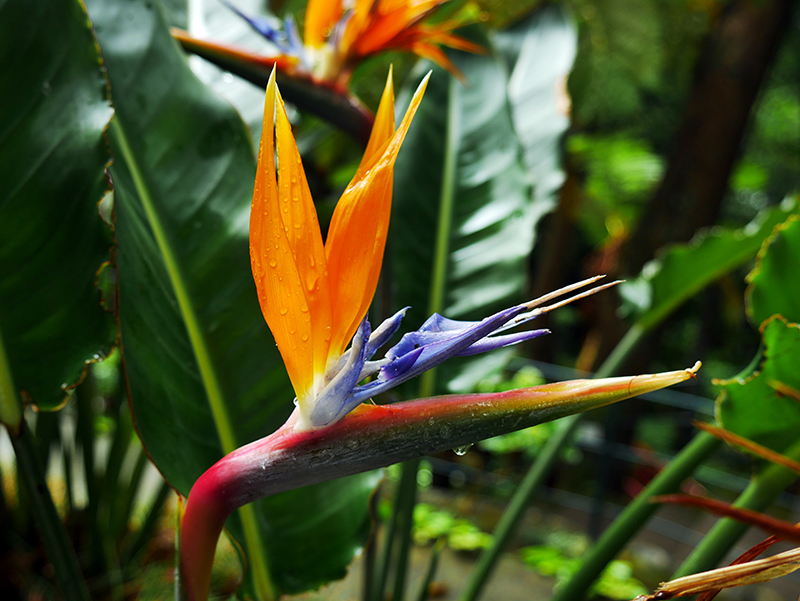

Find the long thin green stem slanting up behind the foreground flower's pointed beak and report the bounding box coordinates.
[460,324,647,601]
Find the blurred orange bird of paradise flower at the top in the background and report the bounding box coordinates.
[172,0,484,143]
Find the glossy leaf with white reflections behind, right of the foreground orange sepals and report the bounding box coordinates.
[390,10,574,391]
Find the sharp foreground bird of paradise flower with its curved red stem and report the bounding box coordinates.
[180,71,699,601]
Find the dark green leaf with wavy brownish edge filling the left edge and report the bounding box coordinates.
[0,0,114,426]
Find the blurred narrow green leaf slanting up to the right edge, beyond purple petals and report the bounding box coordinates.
[620,200,797,329]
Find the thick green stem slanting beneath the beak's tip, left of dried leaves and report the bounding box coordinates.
[552,432,722,601]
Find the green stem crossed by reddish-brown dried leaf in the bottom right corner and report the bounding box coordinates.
[673,443,800,578]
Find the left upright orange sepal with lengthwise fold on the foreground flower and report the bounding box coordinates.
[250,71,331,402]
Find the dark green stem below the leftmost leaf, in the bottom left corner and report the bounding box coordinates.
[11,421,89,601]
